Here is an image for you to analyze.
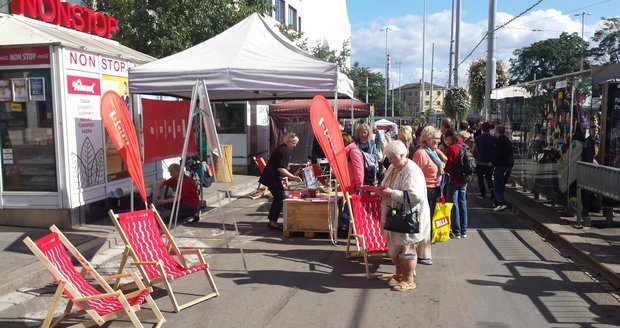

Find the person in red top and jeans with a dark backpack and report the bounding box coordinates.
[443,129,467,239]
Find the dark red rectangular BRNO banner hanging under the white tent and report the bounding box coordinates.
[142,99,196,163]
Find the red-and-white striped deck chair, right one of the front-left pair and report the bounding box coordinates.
[108,205,219,312]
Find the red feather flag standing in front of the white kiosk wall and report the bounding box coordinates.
[101,91,146,203]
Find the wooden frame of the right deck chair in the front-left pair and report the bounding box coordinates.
[108,204,220,312]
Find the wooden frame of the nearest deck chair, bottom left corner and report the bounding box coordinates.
[24,225,166,328]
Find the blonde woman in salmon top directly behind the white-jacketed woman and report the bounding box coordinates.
[413,125,447,265]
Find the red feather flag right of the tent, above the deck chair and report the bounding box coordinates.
[310,96,351,192]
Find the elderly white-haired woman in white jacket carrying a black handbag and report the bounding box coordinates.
[381,141,431,291]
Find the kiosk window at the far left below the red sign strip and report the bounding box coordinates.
[0,69,58,191]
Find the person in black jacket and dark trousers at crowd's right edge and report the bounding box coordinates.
[493,125,514,212]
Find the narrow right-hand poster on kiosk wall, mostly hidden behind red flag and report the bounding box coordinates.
[101,74,130,182]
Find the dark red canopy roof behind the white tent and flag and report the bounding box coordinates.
[269,99,370,118]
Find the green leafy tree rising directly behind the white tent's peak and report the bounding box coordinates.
[83,0,272,58]
